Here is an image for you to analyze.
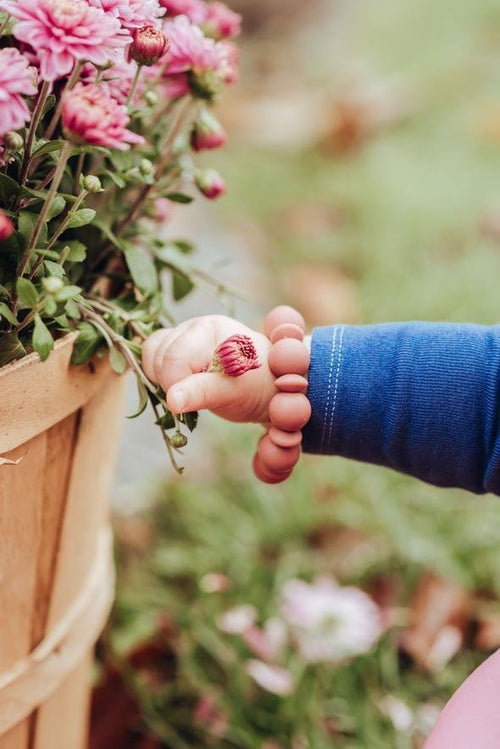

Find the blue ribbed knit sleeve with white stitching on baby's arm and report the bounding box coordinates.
[304,322,500,494]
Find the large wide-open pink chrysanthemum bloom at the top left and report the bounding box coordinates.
[0,0,130,81]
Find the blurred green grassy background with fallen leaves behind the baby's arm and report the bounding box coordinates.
[91,0,500,749]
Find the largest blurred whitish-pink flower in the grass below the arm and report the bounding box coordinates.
[281,578,383,663]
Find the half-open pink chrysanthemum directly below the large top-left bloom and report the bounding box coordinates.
[62,83,144,151]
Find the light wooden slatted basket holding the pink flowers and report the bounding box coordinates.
[0,336,124,749]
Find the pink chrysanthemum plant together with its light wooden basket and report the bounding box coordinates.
[0,0,240,749]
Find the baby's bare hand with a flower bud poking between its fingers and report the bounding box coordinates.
[142,315,276,423]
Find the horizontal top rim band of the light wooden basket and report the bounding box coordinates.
[0,334,118,455]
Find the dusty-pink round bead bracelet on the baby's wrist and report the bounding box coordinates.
[253,306,311,484]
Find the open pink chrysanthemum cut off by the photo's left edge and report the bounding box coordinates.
[0,47,37,138]
